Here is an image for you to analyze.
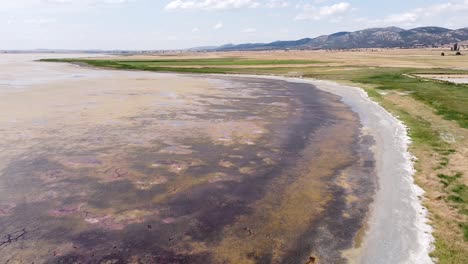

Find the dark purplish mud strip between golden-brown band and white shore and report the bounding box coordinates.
[283,136,377,264]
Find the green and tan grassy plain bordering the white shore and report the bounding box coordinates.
[44,49,468,263]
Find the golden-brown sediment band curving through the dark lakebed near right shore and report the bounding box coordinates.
[211,114,355,263]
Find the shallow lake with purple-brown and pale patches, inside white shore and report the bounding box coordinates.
[0,55,376,263]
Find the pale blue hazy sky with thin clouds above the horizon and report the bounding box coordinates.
[0,0,468,49]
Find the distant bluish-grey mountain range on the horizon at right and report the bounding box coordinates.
[196,27,468,51]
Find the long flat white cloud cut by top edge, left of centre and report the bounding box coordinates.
[165,0,260,10]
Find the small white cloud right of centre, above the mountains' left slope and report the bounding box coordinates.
[296,2,351,20]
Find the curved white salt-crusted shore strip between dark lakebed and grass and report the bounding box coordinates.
[220,75,434,264]
